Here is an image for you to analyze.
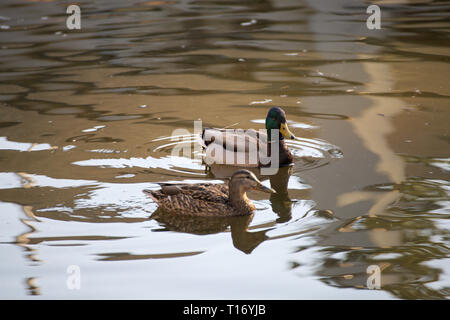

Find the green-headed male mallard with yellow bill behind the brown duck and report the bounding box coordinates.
[201,107,295,167]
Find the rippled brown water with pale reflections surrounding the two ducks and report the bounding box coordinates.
[0,0,450,299]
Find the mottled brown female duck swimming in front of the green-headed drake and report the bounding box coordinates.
[144,170,275,217]
